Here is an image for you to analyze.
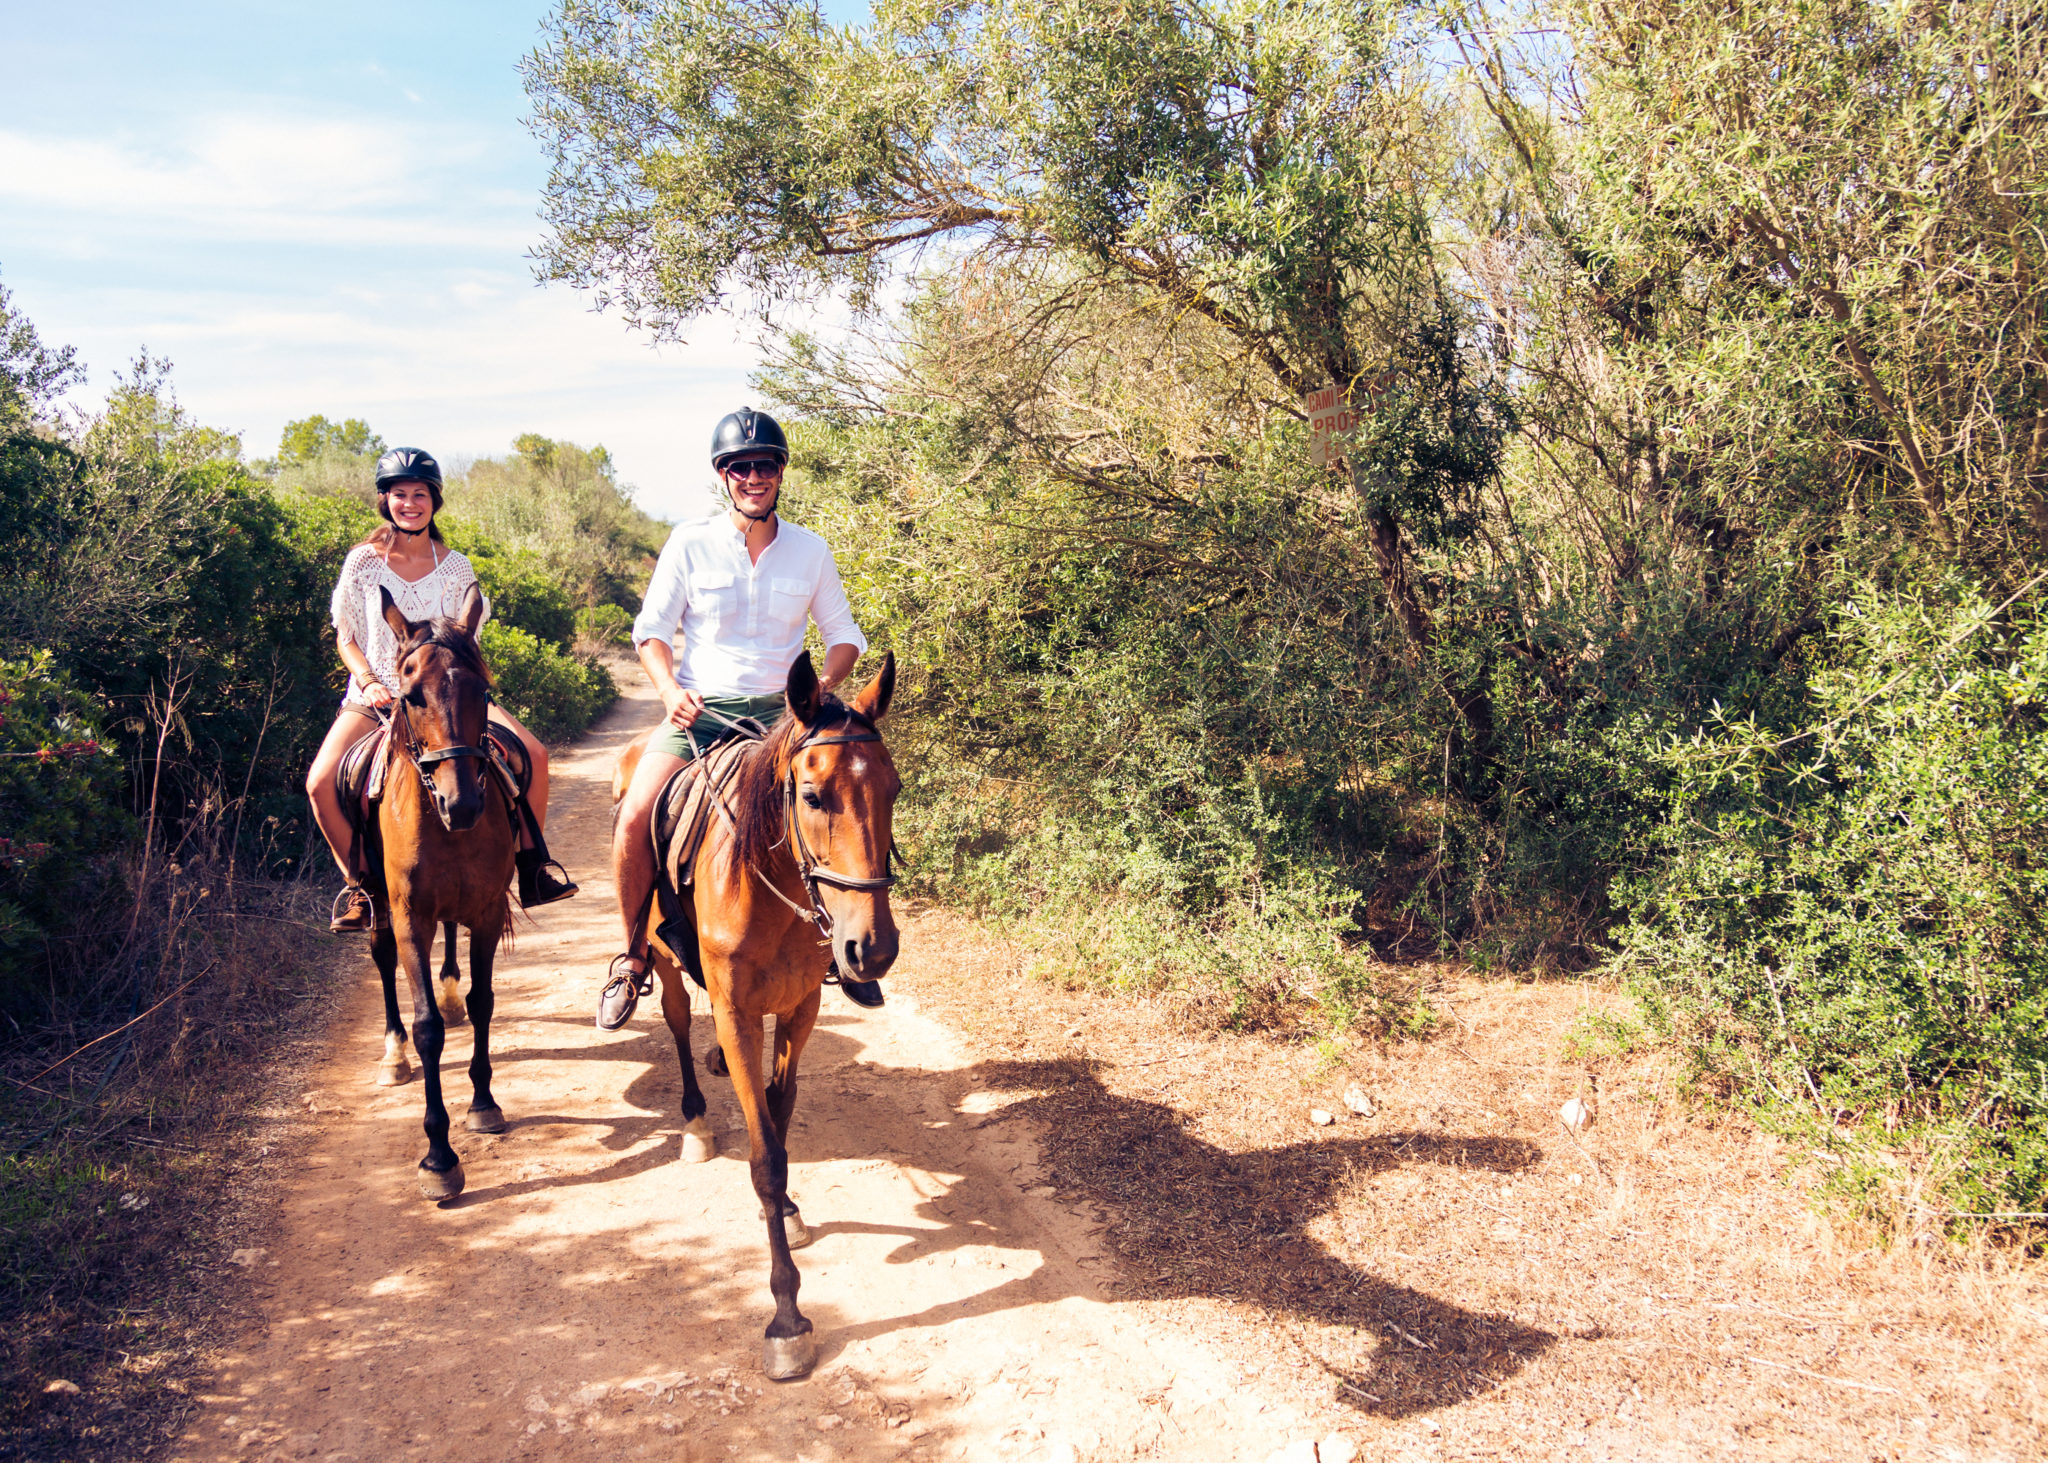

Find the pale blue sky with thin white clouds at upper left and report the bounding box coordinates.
[0,0,866,516]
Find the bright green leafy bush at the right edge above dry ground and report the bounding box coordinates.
[1620,596,2048,1213]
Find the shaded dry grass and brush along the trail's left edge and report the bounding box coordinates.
[0,850,356,1461]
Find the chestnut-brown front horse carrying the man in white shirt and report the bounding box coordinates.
[622,654,901,1381]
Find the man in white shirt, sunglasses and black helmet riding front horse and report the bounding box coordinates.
[598,408,883,1031]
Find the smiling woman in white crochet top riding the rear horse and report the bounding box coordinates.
[305,447,575,934]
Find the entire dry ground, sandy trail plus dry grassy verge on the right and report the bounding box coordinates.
[170,672,2048,1463]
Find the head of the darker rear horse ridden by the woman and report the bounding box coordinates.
[381,584,492,834]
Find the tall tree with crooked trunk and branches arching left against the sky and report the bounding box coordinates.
[524,0,1505,770]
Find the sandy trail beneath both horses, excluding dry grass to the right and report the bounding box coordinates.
[172,672,1294,1463]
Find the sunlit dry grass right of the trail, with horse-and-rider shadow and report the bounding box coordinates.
[909,912,2048,1459]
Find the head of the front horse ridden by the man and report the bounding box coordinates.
[784,652,903,979]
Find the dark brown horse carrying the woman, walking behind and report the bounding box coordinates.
[369,586,518,1199]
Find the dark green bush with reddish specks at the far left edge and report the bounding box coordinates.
[0,652,131,1008]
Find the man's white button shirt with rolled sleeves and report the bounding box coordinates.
[633,512,868,697]
